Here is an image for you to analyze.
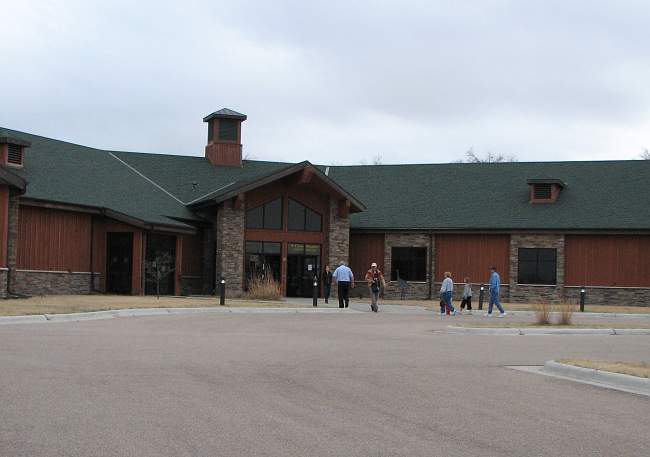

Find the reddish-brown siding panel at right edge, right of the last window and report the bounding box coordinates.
[565,235,650,287]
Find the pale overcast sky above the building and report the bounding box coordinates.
[0,0,650,164]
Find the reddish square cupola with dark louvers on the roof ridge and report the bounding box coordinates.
[203,108,246,167]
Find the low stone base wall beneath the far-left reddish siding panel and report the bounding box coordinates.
[11,270,100,295]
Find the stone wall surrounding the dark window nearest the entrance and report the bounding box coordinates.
[380,233,430,299]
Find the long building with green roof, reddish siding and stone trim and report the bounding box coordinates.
[0,109,650,305]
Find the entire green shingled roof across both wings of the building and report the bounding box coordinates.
[5,125,650,231]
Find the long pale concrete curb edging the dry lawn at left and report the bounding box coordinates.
[0,307,363,325]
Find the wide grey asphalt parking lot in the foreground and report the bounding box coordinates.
[0,311,650,457]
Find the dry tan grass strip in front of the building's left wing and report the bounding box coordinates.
[0,295,306,316]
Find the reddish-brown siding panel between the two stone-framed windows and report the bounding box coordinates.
[435,234,510,284]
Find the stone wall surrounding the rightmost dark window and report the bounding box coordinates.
[502,233,564,303]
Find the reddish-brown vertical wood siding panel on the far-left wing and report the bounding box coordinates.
[17,206,92,271]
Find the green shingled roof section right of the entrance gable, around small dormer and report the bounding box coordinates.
[329,160,650,230]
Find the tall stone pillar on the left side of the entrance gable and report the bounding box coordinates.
[215,201,245,297]
